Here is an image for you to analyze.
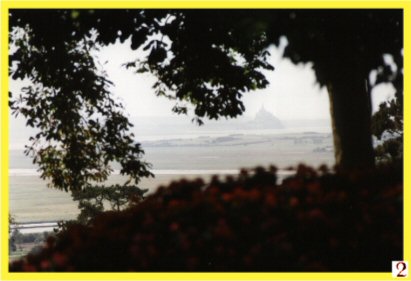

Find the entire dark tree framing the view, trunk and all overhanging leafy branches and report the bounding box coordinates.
[10,10,403,192]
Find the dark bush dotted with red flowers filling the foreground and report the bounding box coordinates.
[10,165,403,272]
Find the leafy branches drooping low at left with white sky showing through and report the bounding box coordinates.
[10,23,151,191]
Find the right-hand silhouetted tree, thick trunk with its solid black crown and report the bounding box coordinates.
[260,10,403,169]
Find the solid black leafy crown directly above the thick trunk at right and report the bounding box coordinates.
[267,9,403,85]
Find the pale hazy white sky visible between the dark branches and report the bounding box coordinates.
[94,37,393,120]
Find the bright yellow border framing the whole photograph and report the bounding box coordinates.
[0,0,411,280]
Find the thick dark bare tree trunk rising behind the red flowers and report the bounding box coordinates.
[327,68,375,170]
